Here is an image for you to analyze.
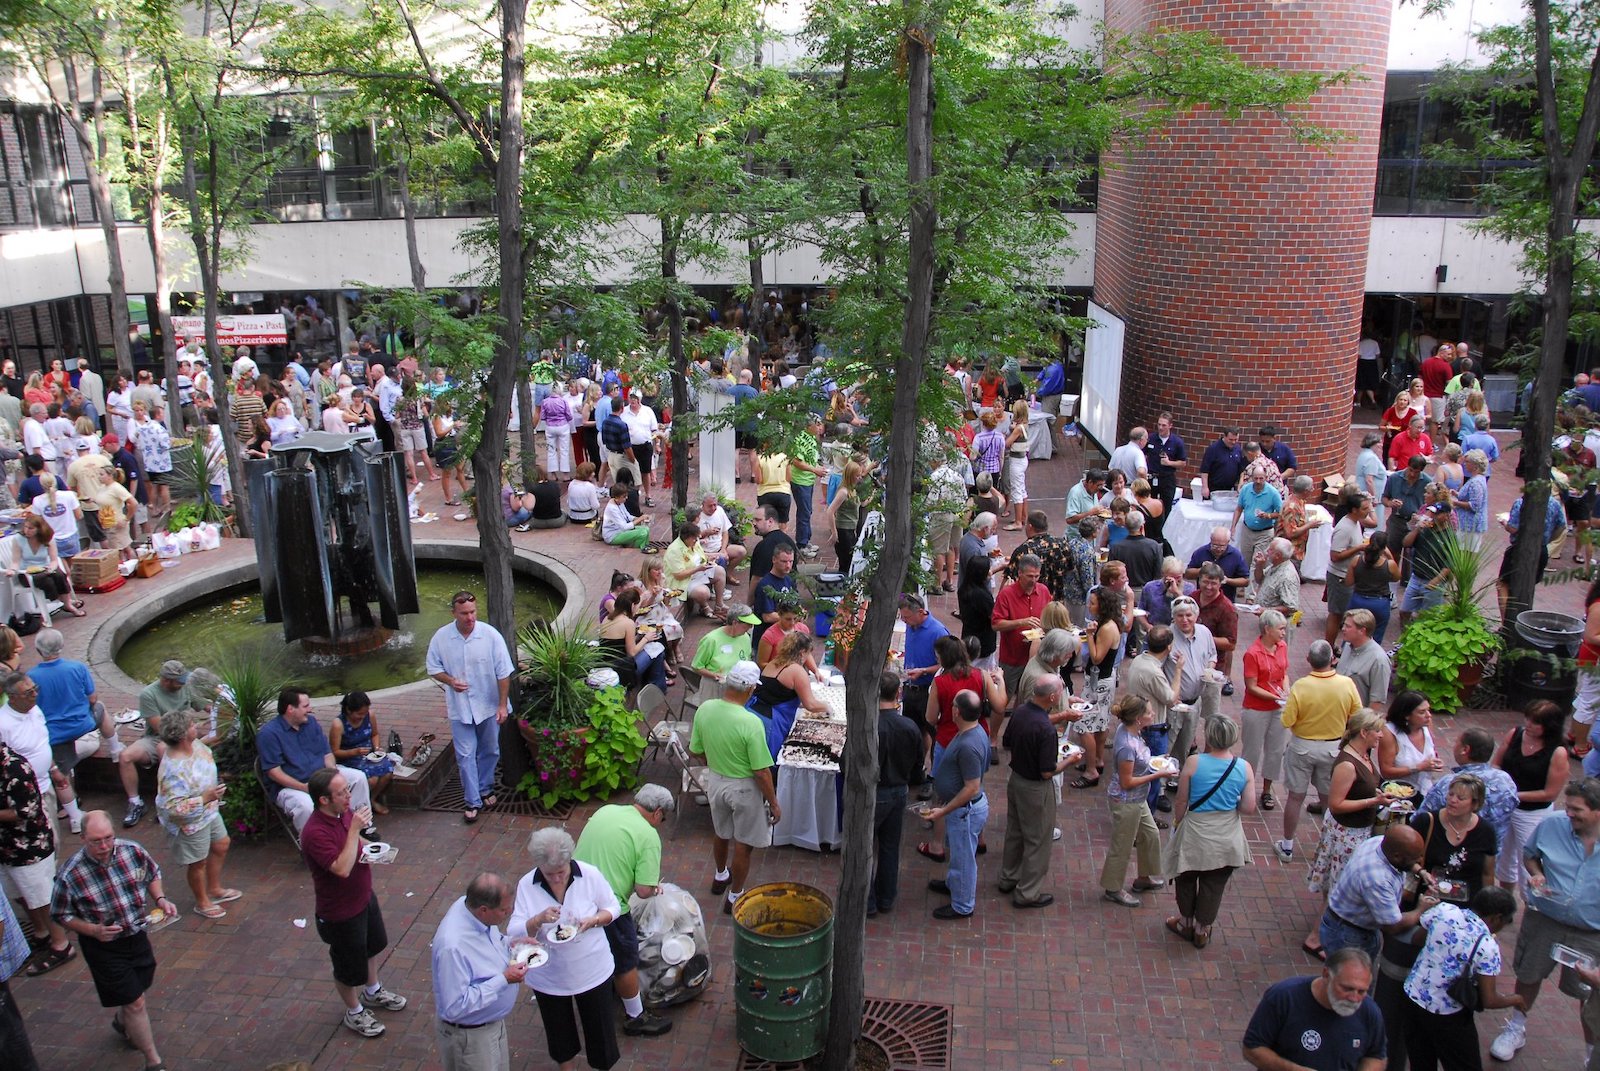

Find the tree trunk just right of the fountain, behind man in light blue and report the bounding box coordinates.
[472,0,533,784]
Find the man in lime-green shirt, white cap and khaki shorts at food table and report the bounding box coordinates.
[690,661,781,914]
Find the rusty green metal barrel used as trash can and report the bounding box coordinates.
[733,882,834,1063]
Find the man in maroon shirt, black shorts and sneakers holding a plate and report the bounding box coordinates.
[301,767,406,1037]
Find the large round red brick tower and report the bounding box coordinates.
[1094,0,1390,479]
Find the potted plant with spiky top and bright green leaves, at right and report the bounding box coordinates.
[1395,531,1501,714]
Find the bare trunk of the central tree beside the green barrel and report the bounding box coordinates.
[822,8,939,1071]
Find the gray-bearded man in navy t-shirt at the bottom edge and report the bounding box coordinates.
[1243,948,1389,1071]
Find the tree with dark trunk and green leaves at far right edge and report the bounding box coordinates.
[1422,0,1600,620]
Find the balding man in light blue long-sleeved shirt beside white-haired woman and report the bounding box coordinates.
[432,872,528,1071]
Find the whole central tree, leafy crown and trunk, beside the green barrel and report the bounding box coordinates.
[763,0,1339,1069]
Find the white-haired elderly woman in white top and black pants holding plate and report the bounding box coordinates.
[506,826,622,1071]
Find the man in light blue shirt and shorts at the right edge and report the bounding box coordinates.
[1490,778,1600,1060]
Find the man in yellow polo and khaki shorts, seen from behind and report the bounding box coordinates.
[1274,640,1362,863]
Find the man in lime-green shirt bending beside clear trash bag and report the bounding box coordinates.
[573,784,678,1037]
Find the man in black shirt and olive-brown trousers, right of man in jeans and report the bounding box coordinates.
[1000,674,1067,908]
